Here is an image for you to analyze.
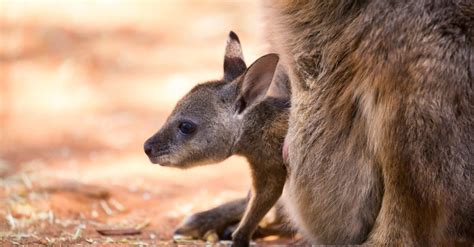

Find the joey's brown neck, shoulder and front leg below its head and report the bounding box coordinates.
[234,98,289,245]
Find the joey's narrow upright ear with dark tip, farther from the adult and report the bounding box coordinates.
[224,31,247,81]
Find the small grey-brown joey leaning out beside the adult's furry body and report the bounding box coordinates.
[144,32,290,246]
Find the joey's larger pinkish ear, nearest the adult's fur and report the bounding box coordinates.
[237,53,279,113]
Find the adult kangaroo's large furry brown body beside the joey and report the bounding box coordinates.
[264,0,474,245]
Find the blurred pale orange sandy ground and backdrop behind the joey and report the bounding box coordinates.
[0,0,265,244]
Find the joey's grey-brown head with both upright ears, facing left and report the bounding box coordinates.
[144,32,278,168]
